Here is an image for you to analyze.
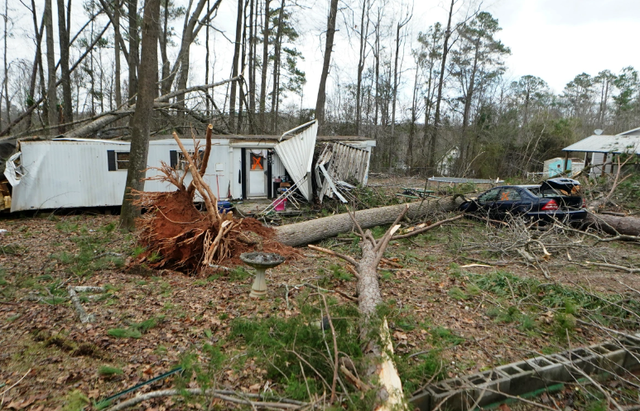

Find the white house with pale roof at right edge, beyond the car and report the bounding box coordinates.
[562,127,640,176]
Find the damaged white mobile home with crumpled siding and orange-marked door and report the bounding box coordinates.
[0,121,375,212]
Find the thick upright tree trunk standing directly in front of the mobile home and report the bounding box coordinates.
[120,0,160,230]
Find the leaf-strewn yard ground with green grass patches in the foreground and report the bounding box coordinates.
[0,190,640,410]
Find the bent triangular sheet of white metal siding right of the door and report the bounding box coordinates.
[274,121,318,201]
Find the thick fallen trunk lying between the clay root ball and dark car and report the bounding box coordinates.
[275,197,462,247]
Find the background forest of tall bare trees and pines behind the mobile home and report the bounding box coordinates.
[0,0,640,178]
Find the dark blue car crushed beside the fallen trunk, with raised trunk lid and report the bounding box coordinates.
[460,178,587,222]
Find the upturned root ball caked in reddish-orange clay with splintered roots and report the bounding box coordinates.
[136,125,290,272]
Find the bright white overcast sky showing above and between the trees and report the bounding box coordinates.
[3,0,640,107]
